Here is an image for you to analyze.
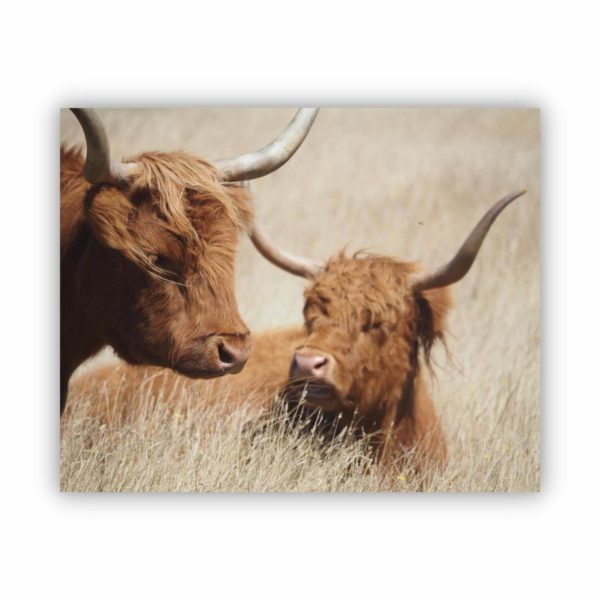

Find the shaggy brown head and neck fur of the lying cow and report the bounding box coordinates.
[286,256,451,463]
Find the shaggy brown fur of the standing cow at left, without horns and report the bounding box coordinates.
[60,147,252,412]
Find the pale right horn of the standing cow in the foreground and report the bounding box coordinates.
[213,108,319,181]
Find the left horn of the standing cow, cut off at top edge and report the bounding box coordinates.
[71,108,134,183]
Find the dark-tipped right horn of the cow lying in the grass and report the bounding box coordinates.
[412,190,527,292]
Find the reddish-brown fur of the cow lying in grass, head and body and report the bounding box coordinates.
[71,255,451,464]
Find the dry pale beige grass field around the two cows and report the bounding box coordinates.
[61,109,540,492]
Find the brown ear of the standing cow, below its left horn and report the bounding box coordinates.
[85,186,135,252]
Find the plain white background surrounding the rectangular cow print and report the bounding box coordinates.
[0,0,600,599]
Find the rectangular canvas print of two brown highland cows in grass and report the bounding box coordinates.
[60,107,540,492]
